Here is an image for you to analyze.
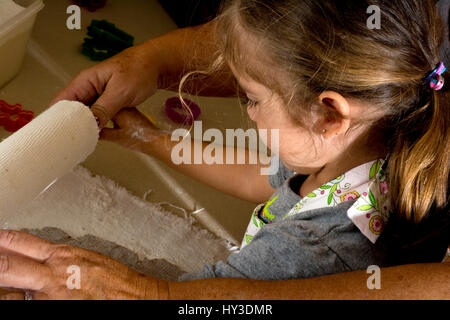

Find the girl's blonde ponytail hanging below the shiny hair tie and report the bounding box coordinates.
[388,85,450,223]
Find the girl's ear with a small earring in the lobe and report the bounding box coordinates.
[316,91,350,139]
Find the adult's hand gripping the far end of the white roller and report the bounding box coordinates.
[51,42,162,129]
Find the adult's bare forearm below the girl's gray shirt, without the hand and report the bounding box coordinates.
[168,262,450,300]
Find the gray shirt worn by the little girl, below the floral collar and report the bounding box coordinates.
[180,158,387,281]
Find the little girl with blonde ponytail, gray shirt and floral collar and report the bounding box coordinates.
[102,0,450,280]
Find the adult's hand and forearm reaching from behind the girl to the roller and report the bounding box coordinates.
[51,21,236,128]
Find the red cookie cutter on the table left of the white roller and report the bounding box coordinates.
[0,100,34,132]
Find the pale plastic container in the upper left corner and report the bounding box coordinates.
[0,0,44,88]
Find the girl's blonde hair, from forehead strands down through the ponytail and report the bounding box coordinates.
[217,0,450,222]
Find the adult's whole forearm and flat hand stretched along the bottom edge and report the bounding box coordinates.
[0,230,450,300]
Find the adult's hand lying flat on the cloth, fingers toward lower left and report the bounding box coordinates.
[0,230,162,300]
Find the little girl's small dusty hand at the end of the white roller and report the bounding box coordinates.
[100,108,164,152]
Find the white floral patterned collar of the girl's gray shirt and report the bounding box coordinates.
[286,160,390,243]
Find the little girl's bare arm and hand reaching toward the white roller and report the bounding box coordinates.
[101,109,275,203]
